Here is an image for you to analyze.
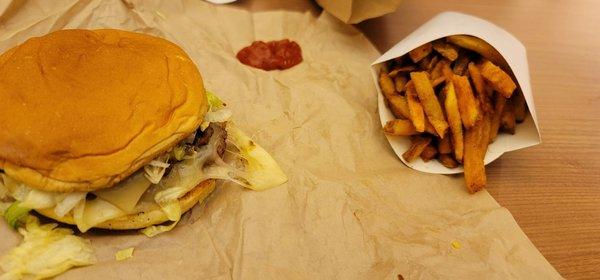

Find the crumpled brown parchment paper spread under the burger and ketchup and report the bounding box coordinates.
[0,0,560,279]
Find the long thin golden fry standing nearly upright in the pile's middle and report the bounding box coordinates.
[443,82,464,162]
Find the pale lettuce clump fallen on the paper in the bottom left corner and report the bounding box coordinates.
[0,215,97,279]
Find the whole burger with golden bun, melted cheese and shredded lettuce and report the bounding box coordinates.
[0,29,287,232]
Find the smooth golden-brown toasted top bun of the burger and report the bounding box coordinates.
[0,29,208,192]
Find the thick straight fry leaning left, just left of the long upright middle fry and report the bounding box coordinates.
[410,72,448,137]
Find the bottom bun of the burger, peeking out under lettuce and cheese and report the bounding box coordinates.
[35,179,215,230]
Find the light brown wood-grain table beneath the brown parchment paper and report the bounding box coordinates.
[241,0,600,279]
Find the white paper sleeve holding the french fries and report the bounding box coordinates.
[371,12,541,174]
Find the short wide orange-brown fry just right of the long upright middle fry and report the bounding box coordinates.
[452,75,481,127]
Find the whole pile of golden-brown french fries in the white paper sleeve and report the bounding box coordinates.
[379,35,527,193]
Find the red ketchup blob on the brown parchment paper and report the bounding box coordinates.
[236,39,302,71]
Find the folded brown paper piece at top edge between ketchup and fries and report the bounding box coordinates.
[316,0,401,23]
